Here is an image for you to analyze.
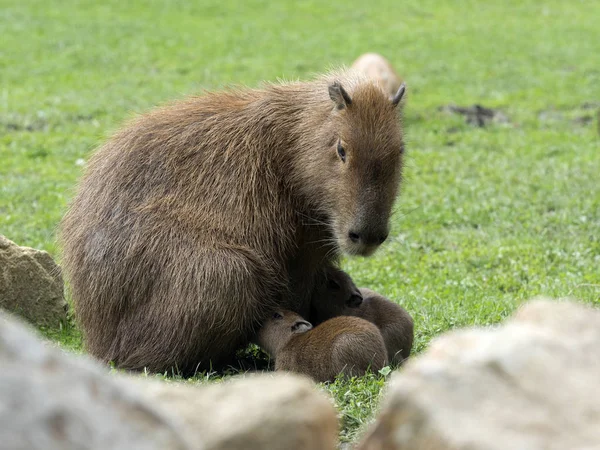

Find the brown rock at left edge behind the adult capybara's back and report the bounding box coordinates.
[0,235,67,327]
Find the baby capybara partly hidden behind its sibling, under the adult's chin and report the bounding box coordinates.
[310,268,414,364]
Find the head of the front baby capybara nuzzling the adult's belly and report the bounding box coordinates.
[257,309,312,356]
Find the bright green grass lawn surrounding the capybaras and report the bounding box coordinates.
[0,0,600,440]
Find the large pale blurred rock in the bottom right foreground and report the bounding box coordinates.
[359,300,600,450]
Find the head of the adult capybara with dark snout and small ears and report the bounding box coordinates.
[319,81,405,256]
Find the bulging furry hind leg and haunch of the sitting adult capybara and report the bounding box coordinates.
[105,248,273,372]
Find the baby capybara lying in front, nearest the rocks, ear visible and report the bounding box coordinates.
[258,310,387,382]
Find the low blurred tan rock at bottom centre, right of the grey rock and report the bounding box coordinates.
[129,374,338,450]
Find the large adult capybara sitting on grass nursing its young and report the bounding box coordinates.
[61,71,404,371]
